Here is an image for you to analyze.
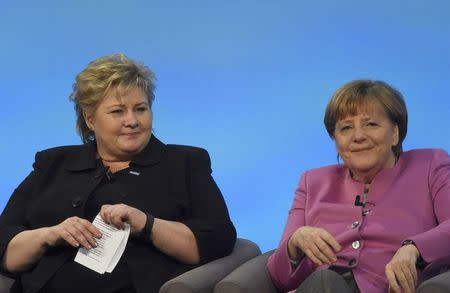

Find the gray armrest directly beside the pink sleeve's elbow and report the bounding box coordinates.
[214,250,277,293]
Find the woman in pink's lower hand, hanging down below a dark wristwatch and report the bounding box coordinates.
[385,244,420,293]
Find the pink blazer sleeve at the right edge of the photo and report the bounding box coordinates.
[410,150,450,263]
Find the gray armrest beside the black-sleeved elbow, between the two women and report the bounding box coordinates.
[159,239,261,293]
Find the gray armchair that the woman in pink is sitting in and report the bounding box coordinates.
[214,250,450,293]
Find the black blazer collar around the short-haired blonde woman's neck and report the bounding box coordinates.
[65,134,166,171]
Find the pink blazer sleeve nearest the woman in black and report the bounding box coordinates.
[267,172,314,292]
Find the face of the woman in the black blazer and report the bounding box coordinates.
[84,87,152,161]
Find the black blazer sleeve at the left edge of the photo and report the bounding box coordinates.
[0,153,47,273]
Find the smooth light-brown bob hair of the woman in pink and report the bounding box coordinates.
[323,80,408,158]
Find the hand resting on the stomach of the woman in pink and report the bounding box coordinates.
[288,226,342,266]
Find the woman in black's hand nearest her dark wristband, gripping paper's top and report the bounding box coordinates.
[100,204,147,234]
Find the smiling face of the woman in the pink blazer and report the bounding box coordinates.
[334,104,399,183]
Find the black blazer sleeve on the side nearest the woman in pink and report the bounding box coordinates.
[179,148,236,263]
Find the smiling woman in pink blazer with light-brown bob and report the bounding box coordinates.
[268,80,450,293]
